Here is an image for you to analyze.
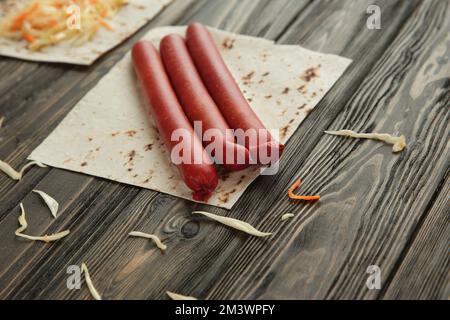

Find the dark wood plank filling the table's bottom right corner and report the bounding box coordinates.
[381,173,450,300]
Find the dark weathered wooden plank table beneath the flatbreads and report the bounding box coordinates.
[0,0,450,299]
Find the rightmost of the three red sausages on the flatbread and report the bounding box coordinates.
[186,23,284,164]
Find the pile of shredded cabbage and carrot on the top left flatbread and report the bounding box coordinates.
[0,0,127,51]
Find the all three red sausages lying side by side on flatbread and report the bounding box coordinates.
[132,23,284,201]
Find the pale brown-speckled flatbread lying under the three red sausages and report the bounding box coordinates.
[29,27,351,209]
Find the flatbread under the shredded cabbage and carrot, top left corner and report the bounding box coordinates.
[0,0,173,65]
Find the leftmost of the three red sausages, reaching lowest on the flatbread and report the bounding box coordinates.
[132,41,218,201]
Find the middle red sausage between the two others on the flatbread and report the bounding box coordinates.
[160,35,249,171]
